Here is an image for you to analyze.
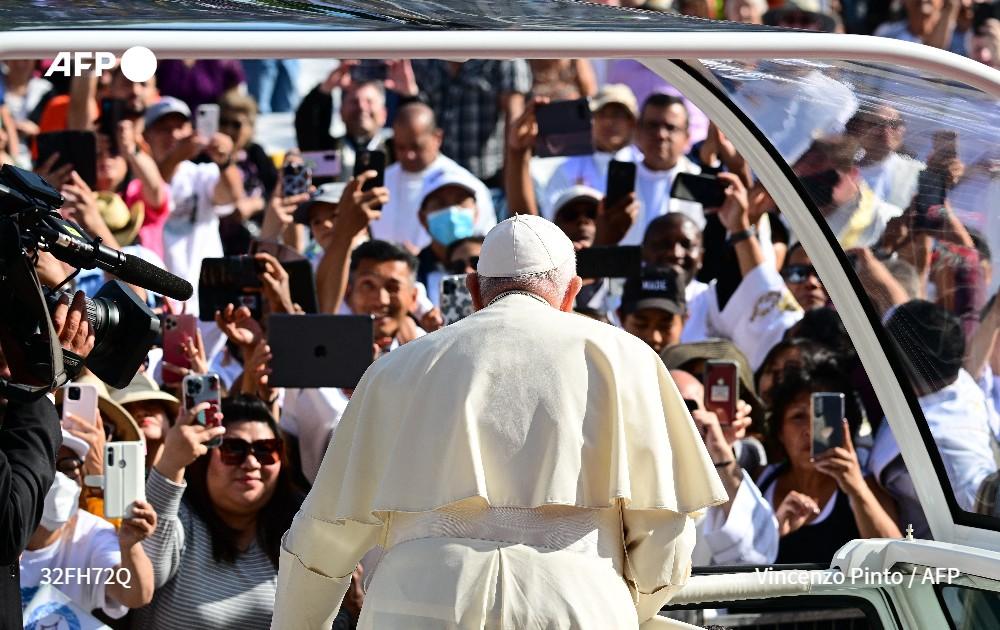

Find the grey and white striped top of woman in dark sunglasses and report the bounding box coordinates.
[132,469,278,630]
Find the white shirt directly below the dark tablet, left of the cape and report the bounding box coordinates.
[281,387,349,483]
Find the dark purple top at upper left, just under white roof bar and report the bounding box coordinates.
[156,59,243,112]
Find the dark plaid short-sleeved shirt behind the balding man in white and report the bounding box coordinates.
[413,59,531,183]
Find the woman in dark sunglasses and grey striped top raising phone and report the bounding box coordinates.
[133,396,302,629]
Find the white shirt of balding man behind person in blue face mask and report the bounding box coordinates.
[371,154,497,249]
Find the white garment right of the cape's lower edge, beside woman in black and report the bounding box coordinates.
[691,470,780,566]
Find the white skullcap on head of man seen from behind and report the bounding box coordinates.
[476,214,576,278]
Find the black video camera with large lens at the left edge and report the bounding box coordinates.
[0,165,167,400]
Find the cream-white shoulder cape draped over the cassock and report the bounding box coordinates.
[316,295,726,524]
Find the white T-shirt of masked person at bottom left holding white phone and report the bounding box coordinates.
[20,510,128,619]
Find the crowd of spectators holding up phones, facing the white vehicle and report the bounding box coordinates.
[0,0,1000,628]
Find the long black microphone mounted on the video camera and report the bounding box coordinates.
[46,220,194,301]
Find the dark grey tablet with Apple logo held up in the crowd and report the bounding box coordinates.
[267,314,375,389]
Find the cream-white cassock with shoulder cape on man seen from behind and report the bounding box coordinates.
[272,294,727,630]
